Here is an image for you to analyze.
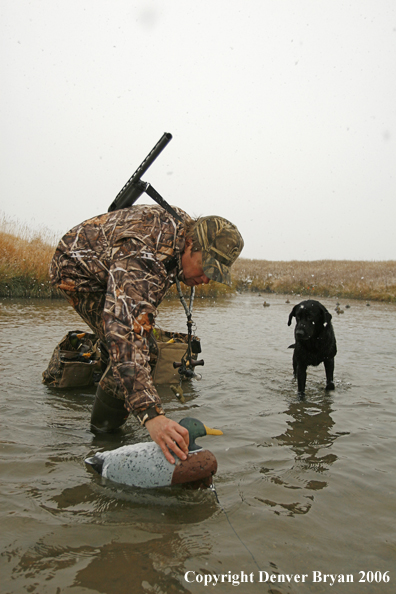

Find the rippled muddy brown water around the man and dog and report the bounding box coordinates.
[0,294,396,594]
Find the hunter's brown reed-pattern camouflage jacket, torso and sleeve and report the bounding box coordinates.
[50,205,189,414]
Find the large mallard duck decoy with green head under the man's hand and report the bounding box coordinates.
[85,417,223,489]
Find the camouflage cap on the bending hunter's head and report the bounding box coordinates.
[194,216,244,285]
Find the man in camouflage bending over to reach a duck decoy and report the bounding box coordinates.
[50,205,243,463]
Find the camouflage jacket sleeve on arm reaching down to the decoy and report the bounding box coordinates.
[103,242,167,415]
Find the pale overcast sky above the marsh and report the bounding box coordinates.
[0,0,396,260]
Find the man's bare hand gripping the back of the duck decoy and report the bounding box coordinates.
[145,415,189,464]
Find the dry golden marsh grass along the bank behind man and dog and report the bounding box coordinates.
[0,216,396,303]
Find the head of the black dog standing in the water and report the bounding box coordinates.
[287,299,332,340]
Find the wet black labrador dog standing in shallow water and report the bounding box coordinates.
[287,299,337,395]
